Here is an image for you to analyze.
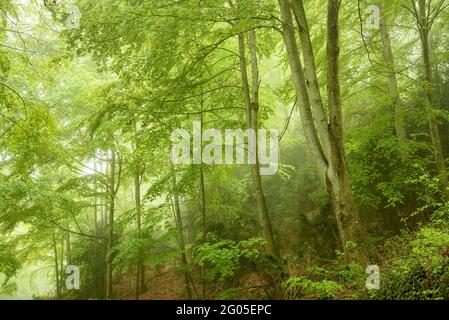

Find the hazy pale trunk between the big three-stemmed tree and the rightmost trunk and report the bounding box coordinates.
[380,10,408,163]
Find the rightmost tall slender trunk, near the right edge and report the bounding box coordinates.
[416,0,445,173]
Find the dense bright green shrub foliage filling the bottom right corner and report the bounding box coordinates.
[379,206,449,300]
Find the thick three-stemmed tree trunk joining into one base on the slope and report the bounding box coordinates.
[279,0,366,260]
